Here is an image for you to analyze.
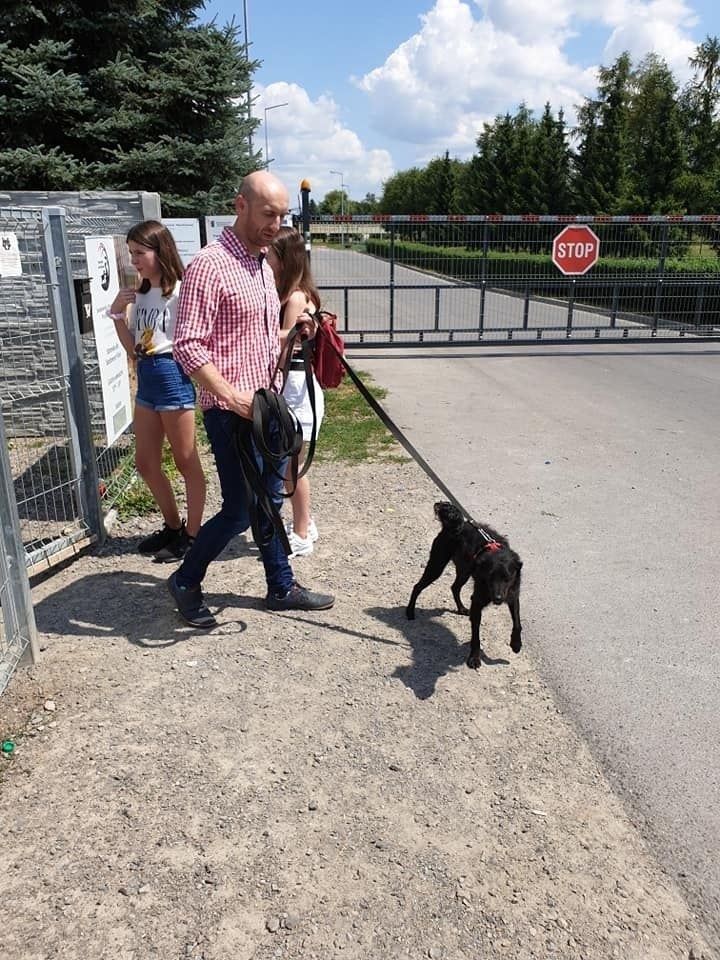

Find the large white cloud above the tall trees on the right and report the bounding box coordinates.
[358,0,696,160]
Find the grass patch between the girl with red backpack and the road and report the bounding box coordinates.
[320,370,407,464]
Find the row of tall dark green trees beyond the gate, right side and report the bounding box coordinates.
[380,37,720,214]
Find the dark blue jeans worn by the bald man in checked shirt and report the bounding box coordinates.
[176,407,294,596]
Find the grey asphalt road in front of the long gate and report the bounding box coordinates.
[348,341,720,947]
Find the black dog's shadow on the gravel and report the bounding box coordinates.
[366,606,510,700]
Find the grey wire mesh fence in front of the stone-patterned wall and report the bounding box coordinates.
[0,207,135,572]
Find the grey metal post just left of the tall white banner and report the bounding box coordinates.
[42,207,106,543]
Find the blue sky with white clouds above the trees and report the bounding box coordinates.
[200,0,720,206]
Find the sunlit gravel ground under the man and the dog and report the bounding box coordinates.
[0,454,717,960]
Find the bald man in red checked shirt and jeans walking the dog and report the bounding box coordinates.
[168,170,335,628]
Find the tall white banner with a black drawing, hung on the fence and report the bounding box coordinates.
[85,237,132,446]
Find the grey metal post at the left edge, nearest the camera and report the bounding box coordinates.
[0,409,39,676]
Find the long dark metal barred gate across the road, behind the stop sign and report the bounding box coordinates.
[306,215,720,347]
